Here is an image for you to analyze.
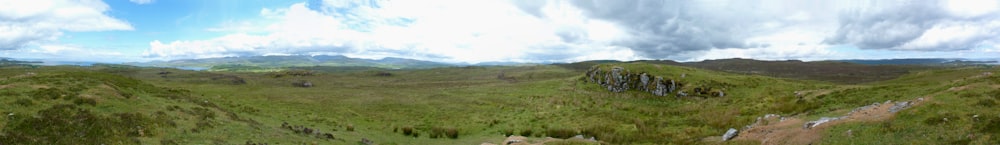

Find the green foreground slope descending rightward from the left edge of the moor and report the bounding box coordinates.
[0,67,292,144]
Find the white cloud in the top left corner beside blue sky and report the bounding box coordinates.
[0,0,133,50]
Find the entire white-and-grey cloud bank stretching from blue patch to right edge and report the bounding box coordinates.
[143,0,1000,63]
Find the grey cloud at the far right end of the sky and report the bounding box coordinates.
[826,1,1000,51]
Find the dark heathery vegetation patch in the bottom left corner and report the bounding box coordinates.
[0,104,163,144]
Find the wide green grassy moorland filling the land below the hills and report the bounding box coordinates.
[0,62,1000,145]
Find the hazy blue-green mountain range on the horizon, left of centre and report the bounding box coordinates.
[125,55,454,70]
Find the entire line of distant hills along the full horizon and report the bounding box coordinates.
[11,55,1000,73]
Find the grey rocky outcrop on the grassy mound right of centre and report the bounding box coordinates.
[586,66,683,96]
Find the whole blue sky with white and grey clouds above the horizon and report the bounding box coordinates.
[0,0,1000,63]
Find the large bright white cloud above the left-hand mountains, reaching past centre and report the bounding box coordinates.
[143,0,636,63]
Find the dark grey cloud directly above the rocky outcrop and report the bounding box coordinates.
[573,0,758,58]
